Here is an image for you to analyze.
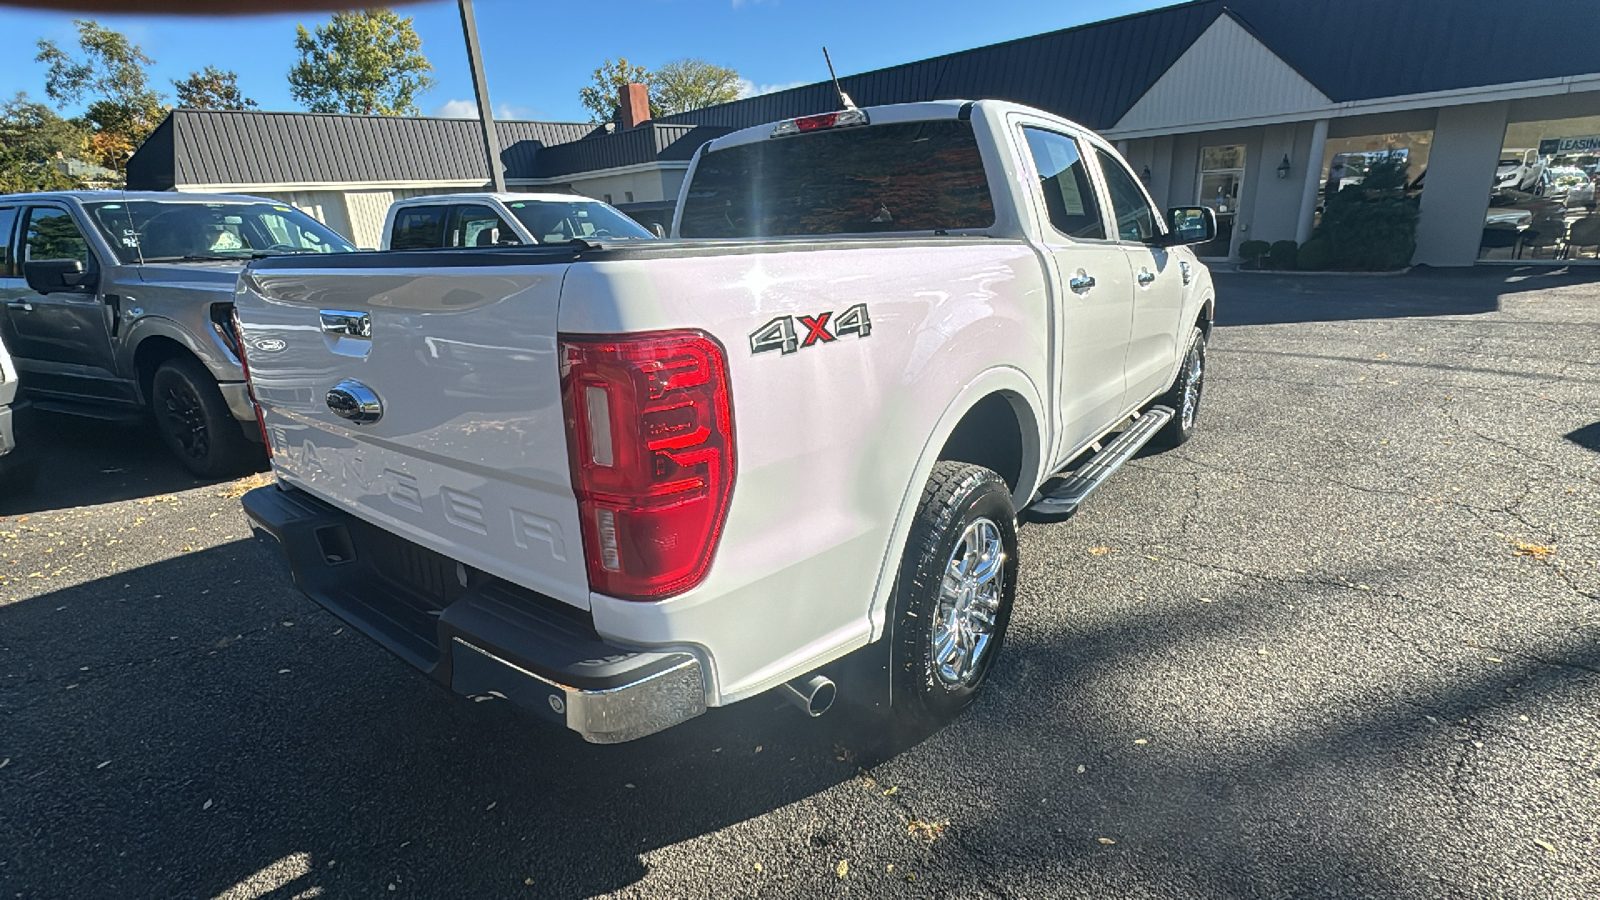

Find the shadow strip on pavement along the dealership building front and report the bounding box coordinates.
[1214,266,1600,327]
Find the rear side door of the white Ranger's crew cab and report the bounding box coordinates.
[1022,127,1134,464]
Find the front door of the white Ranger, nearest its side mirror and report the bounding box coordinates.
[1094,147,1189,405]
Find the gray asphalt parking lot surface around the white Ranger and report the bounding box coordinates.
[0,267,1600,900]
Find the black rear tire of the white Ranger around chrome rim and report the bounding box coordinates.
[890,460,1018,730]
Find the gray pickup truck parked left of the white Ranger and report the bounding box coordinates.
[0,191,355,477]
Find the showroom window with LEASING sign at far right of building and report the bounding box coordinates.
[1478,115,1600,263]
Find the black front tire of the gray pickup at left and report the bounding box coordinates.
[150,357,256,479]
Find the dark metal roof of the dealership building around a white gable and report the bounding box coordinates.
[664,0,1600,130]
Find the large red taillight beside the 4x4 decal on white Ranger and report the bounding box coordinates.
[562,331,733,601]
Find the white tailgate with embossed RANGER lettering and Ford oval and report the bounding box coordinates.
[235,255,589,609]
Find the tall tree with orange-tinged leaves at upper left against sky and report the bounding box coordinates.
[34,19,166,171]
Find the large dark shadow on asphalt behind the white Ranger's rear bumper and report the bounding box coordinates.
[0,540,856,898]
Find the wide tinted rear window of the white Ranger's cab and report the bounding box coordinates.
[678,119,995,237]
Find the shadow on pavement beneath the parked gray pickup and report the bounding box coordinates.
[0,413,264,516]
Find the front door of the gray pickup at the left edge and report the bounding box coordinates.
[3,207,131,400]
